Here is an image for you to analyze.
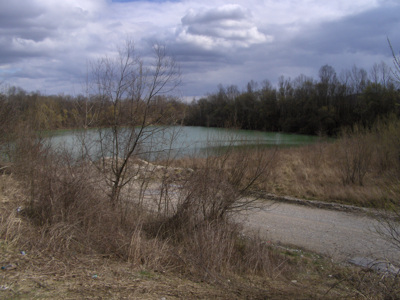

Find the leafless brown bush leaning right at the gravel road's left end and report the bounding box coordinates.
[167,141,275,224]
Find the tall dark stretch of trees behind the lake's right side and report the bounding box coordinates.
[185,62,400,135]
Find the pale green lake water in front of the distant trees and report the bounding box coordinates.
[49,126,319,160]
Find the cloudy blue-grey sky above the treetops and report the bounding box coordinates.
[0,0,400,98]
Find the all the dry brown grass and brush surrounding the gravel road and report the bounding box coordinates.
[0,119,398,299]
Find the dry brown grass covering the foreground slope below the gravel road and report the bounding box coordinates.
[0,166,395,299]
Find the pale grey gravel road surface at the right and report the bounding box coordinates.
[239,202,400,265]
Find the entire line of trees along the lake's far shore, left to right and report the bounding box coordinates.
[0,63,400,136]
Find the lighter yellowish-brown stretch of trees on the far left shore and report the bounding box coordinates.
[0,86,186,131]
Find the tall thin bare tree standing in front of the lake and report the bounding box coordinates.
[91,40,181,206]
